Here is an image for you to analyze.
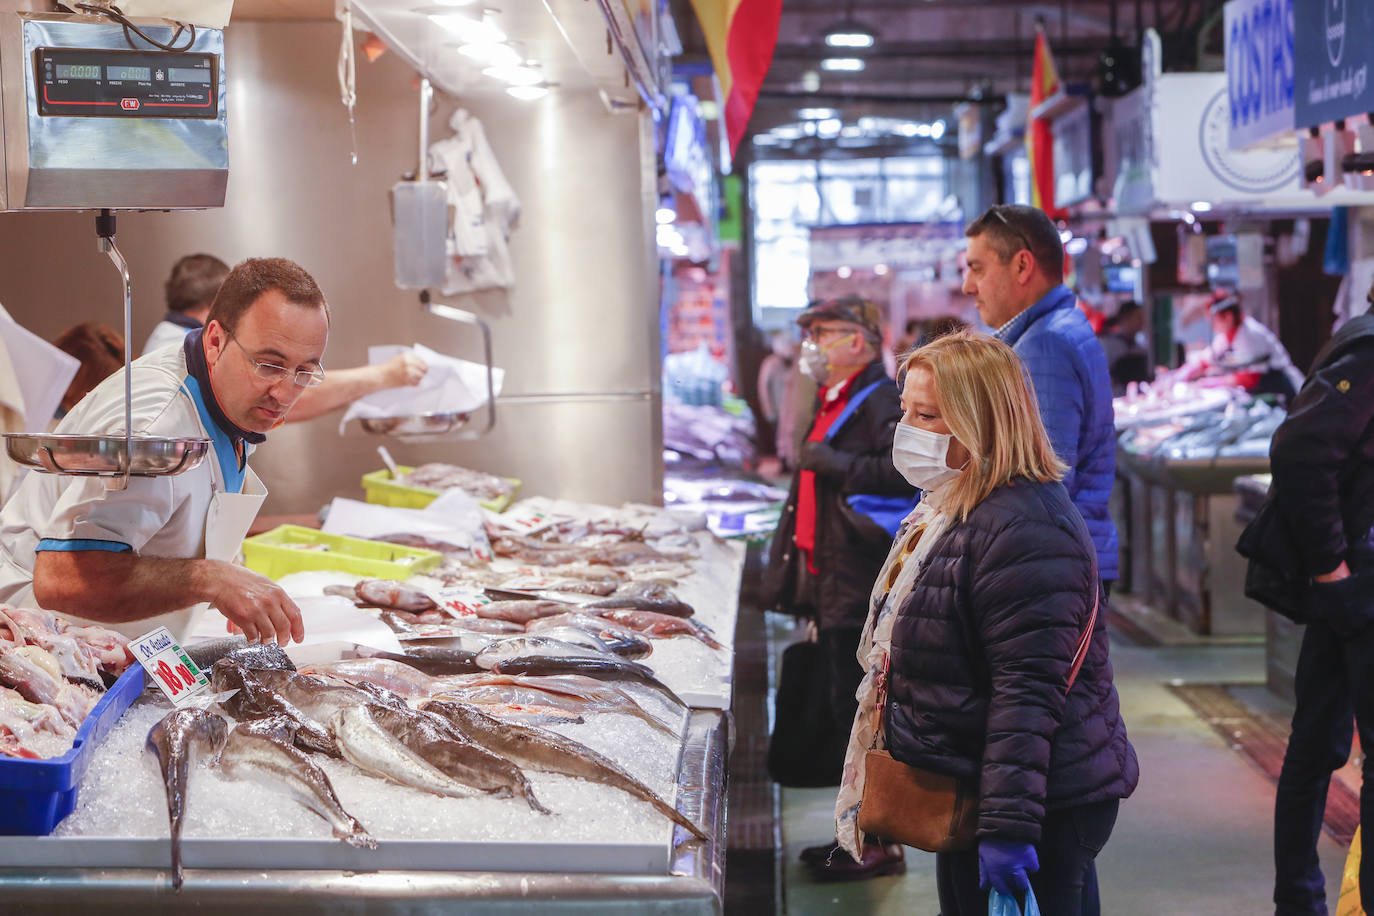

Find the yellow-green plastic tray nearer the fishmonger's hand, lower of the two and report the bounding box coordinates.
[243,525,444,580]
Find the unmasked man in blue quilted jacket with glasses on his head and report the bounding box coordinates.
[963,206,1117,597]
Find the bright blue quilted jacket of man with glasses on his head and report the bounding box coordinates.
[998,286,1118,581]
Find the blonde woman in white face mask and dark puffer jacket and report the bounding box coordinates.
[835,332,1139,916]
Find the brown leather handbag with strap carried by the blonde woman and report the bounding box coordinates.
[859,590,1099,853]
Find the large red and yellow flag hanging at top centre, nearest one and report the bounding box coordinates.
[691,0,782,158]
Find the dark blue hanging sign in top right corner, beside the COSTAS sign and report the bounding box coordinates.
[1293,0,1374,128]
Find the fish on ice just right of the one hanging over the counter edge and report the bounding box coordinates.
[220,720,376,849]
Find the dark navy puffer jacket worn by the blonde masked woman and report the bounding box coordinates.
[883,479,1139,843]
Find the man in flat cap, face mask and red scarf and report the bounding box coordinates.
[764,298,915,880]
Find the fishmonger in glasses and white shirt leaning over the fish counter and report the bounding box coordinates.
[0,258,330,645]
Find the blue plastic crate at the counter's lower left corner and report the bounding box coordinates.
[0,663,144,836]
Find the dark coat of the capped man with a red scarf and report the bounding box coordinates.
[764,360,915,629]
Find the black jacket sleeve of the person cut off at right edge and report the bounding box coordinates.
[1270,347,1374,575]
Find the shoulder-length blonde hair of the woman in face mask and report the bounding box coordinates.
[901,331,1069,520]
